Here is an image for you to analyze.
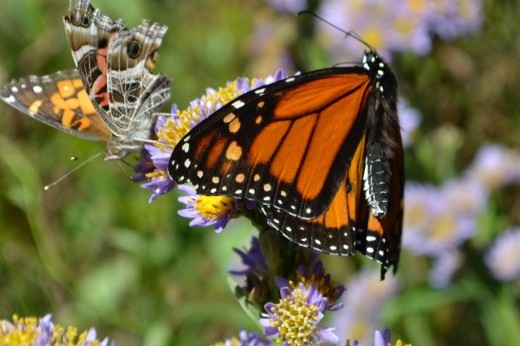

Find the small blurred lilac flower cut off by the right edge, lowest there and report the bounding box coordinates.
[484,227,520,281]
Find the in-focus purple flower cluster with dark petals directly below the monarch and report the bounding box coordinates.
[231,237,344,345]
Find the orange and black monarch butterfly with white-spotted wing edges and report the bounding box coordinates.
[168,38,403,278]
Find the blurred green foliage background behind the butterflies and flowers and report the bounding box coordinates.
[0,0,520,345]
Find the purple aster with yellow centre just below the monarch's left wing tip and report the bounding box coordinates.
[178,185,236,233]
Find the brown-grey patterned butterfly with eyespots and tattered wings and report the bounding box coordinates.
[0,0,170,160]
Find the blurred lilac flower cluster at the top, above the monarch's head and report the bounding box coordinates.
[319,0,482,60]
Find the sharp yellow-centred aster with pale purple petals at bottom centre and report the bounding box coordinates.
[260,283,339,345]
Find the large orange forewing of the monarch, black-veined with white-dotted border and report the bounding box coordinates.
[169,67,371,219]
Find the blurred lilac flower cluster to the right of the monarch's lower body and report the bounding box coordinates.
[403,144,520,287]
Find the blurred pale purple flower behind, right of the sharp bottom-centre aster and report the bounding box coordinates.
[332,268,399,345]
